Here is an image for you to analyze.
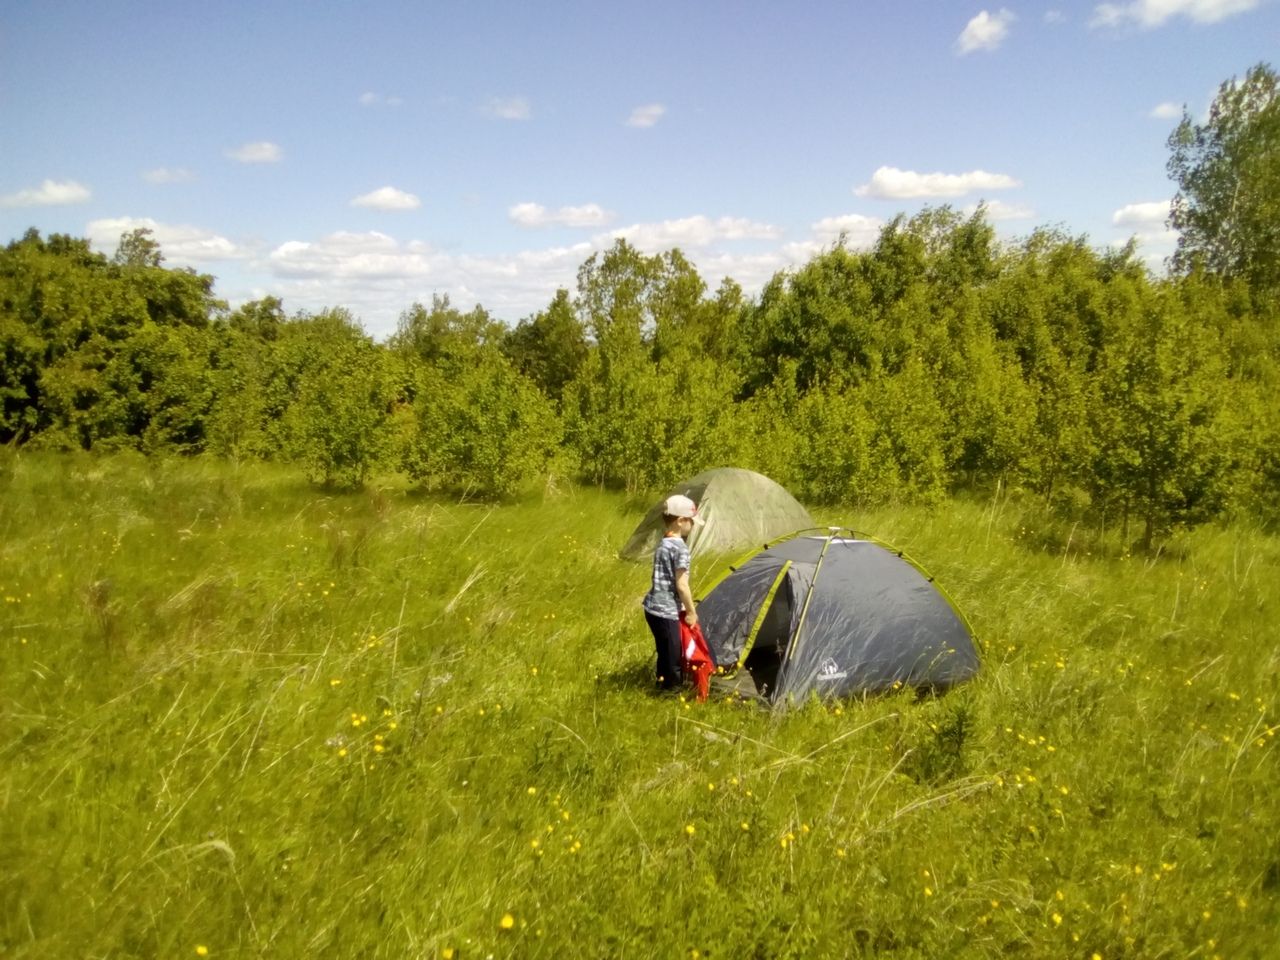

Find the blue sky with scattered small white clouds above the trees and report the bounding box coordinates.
[0,0,1280,338]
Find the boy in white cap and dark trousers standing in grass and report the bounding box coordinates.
[641,494,703,690]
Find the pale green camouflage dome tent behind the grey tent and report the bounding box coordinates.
[618,467,813,561]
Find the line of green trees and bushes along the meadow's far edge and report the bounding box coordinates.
[0,65,1280,544]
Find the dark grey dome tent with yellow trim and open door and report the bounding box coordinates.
[698,529,979,704]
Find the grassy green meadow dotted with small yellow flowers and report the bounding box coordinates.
[0,451,1280,960]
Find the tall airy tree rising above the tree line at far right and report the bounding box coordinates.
[1169,63,1280,298]
